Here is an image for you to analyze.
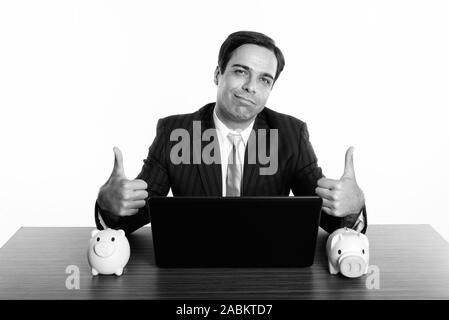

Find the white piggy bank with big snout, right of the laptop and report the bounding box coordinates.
[326,228,369,278]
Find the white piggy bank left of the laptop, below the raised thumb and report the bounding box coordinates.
[87,229,131,276]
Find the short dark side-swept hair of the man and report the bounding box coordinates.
[218,31,285,81]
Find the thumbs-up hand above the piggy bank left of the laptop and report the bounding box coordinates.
[97,147,148,219]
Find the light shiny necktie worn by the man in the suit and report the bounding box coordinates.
[226,133,242,197]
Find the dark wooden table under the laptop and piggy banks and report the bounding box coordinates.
[0,225,449,300]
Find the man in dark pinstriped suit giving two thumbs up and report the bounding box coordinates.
[95,31,367,234]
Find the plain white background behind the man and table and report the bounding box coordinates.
[0,0,449,245]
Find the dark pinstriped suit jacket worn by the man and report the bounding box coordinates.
[95,103,368,234]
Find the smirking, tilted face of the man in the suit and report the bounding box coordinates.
[215,44,277,127]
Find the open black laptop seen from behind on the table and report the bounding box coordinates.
[148,196,322,268]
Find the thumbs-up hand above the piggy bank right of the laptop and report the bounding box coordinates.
[315,147,365,217]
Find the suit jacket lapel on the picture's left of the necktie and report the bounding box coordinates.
[197,103,222,197]
